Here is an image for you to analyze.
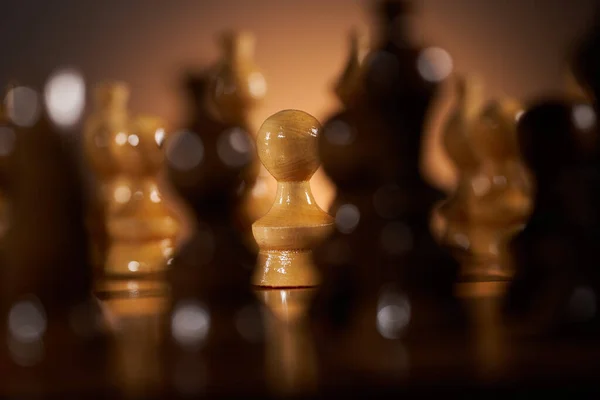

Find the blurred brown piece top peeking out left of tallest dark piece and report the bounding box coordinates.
[334,30,369,105]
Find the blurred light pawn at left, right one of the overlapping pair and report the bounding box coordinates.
[105,116,179,276]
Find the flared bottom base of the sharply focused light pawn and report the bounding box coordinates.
[252,250,321,288]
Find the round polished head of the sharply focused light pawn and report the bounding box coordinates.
[256,110,321,182]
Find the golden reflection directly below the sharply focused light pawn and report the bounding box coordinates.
[257,288,317,395]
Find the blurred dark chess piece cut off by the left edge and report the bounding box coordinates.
[0,87,110,398]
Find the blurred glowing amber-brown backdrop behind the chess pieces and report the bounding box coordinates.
[0,0,595,191]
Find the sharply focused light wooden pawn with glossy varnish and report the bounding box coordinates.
[252,110,333,287]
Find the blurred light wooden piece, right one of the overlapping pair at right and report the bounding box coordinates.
[462,100,532,279]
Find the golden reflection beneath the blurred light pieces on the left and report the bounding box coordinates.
[97,279,168,398]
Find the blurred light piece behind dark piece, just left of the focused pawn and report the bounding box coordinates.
[208,32,274,238]
